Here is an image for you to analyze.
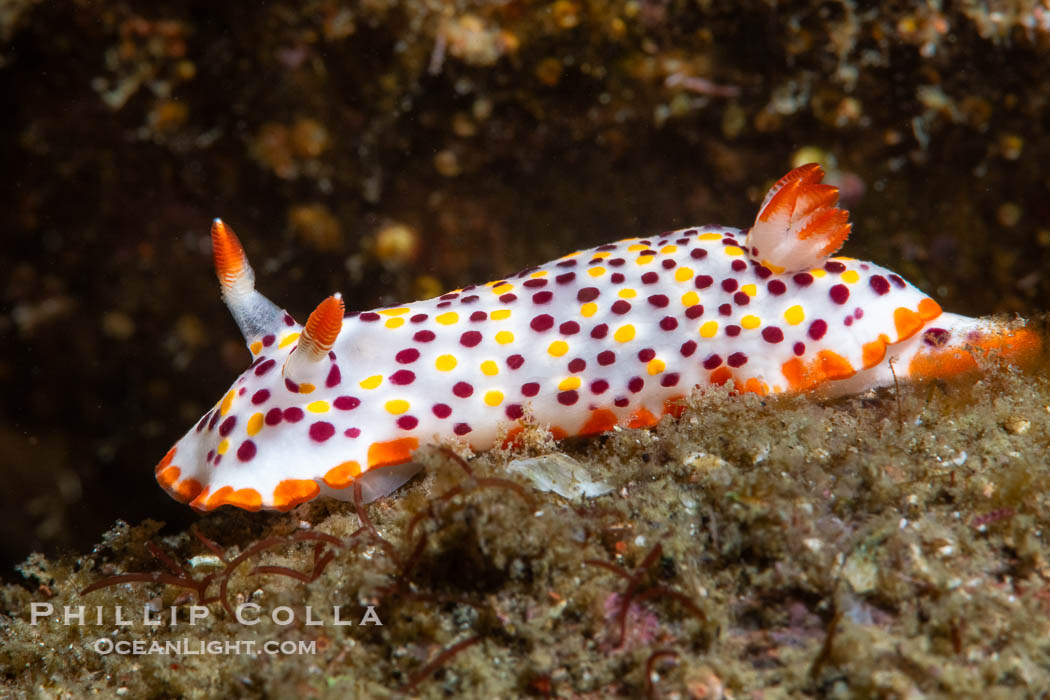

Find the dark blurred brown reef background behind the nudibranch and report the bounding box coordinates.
[0,0,1050,578]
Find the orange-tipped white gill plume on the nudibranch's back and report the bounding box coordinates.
[748,163,851,273]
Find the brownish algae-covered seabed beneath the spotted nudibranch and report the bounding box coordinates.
[0,335,1050,698]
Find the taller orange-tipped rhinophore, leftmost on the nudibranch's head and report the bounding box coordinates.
[211,218,285,345]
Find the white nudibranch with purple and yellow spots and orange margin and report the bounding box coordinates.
[155,164,1038,510]
